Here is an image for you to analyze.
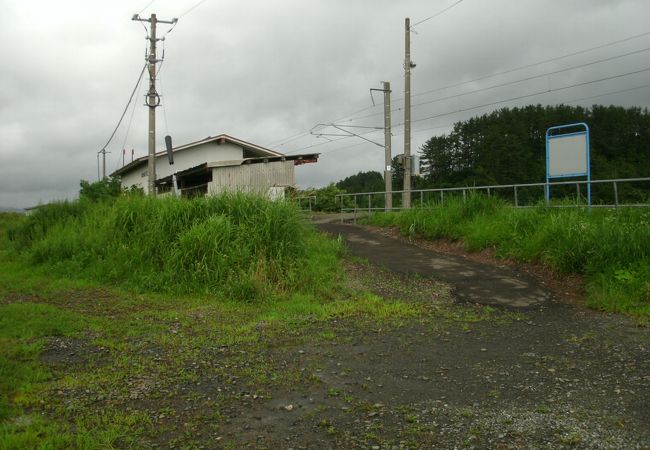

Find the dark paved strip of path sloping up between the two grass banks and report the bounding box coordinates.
[318,223,551,308]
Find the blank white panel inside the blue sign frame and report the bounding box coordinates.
[548,134,587,178]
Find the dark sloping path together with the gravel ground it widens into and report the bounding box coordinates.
[208,224,650,449]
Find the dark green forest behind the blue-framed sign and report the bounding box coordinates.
[420,105,650,187]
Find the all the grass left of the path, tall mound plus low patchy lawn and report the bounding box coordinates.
[0,196,436,448]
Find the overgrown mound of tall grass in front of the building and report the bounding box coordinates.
[9,194,339,300]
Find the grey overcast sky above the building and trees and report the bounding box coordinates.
[0,0,650,207]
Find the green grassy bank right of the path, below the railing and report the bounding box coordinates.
[368,195,650,320]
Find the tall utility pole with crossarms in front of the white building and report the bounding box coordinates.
[132,14,178,196]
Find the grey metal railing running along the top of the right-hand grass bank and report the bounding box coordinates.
[336,178,650,218]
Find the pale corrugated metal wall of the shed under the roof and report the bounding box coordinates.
[208,161,295,194]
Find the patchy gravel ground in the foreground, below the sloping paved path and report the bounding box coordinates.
[21,227,650,449]
